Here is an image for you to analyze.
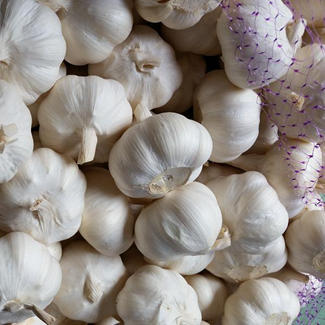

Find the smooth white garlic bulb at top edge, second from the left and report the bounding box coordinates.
[40,0,133,65]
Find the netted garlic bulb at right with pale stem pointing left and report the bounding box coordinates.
[230,139,322,218]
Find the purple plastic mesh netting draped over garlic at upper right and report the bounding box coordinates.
[221,0,325,207]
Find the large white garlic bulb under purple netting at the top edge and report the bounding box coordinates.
[217,0,305,89]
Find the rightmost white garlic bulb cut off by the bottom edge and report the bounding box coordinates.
[222,278,300,325]
